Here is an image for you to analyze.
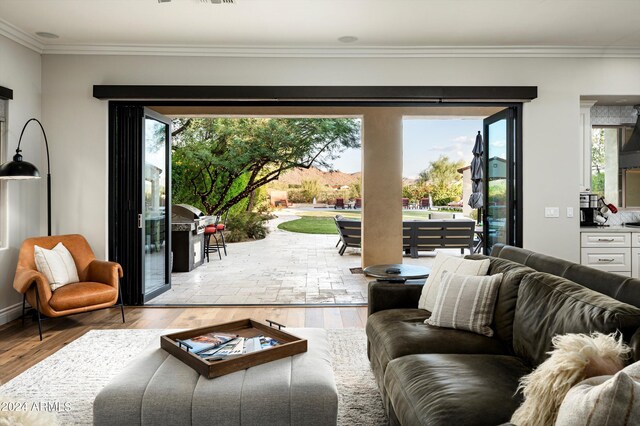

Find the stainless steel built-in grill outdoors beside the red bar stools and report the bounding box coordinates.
[171,204,215,272]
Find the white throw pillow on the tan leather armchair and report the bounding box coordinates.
[34,243,80,291]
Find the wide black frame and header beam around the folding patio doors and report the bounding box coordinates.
[105,85,538,305]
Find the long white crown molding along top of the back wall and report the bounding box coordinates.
[42,44,640,59]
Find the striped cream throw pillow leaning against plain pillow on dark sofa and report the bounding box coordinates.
[425,271,502,337]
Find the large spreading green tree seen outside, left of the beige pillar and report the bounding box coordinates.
[172,118,360,215]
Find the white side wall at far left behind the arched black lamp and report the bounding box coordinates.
[0,36,42,324]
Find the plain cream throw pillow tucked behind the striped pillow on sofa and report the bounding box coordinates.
[418,253,489,312]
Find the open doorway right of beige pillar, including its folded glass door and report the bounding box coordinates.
[403,108,521,266]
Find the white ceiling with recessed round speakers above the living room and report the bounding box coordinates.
[0,0,640,55]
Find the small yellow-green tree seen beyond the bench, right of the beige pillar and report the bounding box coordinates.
[417,155,464,205]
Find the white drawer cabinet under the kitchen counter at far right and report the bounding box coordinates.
[580,232,640,278]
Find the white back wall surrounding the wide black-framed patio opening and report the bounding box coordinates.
[42,55,640,261]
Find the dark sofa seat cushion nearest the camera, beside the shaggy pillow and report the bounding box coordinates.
[384,354,530,426]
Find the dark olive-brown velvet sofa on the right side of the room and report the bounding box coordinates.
[366,245,640,425]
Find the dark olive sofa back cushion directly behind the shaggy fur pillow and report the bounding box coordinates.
[513,272,640,366]
